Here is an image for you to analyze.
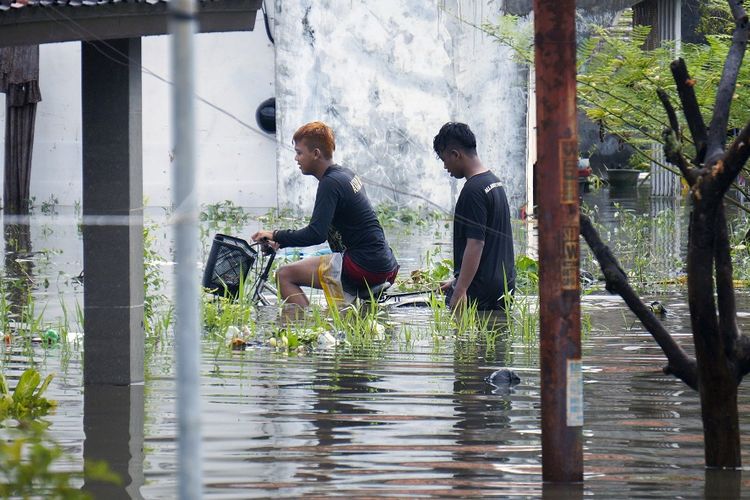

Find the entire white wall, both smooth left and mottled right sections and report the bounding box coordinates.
[0,0,527,215]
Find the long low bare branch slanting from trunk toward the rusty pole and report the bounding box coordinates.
[580,214,698,389]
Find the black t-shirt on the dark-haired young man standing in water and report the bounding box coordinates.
[453,171,516,309]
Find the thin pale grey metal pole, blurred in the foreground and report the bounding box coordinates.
[169,0,202,494]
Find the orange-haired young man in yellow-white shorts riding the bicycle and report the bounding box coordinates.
[252,121,398,307]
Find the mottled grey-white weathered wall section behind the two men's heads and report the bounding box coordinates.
[274,0,527,210]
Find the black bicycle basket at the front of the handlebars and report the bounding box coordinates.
[203,234,258,297]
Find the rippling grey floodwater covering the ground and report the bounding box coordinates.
[0,185,750,499]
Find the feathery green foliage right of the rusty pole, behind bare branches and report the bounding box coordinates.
[578,21,750,169]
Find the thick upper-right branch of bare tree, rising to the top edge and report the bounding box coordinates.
[705,4,750,166]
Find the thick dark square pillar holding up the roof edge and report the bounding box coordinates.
[81,38,144,385]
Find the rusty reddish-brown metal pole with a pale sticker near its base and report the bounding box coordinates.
[534,0,583,482]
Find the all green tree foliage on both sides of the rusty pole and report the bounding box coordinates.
[488,8,750,174]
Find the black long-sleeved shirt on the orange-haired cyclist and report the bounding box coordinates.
[276,165,397,273]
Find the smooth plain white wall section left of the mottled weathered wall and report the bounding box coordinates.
[0,13,276,207]
